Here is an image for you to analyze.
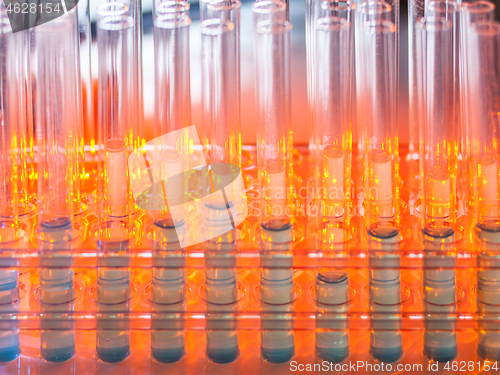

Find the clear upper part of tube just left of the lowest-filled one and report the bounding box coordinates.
[252,0,293,230]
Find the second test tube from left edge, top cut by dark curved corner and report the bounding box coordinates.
[33,9,82,362]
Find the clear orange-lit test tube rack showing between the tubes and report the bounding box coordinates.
[0,147,500,374]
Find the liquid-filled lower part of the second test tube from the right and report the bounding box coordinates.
[423,231,457,362]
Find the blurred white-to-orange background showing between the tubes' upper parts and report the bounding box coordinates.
[90,0,500,144]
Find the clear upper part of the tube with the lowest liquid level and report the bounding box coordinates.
[313,2,352,238]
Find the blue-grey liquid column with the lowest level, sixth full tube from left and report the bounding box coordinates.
[316,271,349,363]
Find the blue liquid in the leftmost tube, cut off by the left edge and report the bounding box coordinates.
[0,269,21,362]
